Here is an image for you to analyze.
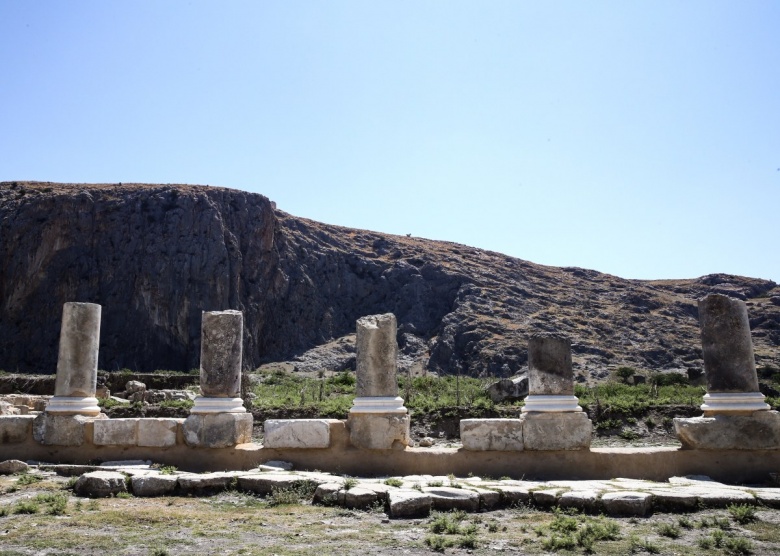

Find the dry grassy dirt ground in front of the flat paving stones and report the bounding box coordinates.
[0,471,780,556]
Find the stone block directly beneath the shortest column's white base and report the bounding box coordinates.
[521,412,593,450]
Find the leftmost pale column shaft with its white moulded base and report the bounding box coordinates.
[46,303,101,416]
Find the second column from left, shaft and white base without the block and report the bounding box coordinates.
[190,311,246,413]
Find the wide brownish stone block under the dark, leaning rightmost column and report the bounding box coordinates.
[674,411,780,450]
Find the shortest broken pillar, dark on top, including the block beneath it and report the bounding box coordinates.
[521,335,593,450]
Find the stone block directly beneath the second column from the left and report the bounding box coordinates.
[182,413,252,448]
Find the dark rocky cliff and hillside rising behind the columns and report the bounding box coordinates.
[0,182,780,376]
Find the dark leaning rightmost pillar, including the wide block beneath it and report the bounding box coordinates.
[674,294,780,450]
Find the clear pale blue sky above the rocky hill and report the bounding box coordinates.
[0,0,780,282]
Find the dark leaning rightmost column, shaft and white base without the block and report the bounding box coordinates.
[699,294,769,415]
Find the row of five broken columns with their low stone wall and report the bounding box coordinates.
[0,294,780,482]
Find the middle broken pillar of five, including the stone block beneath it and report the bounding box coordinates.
[347,313,411,450]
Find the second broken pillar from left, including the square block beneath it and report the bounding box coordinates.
[182,311,253,448]
